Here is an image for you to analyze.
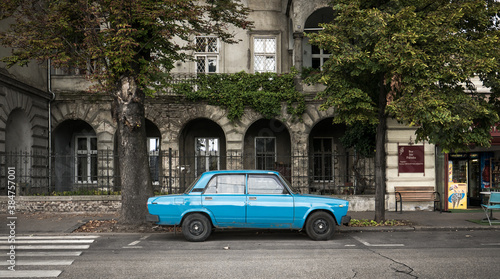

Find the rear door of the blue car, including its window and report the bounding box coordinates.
[201,174,246,227]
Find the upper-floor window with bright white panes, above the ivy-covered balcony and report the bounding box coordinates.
[253,37,276,73]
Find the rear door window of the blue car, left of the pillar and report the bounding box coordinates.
[204,174,245,194]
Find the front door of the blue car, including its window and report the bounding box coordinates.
[247,174,294,228]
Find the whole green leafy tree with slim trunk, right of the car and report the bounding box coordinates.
[308,0,500,220]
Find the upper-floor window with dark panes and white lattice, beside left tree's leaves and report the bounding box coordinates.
[195,36,219,74]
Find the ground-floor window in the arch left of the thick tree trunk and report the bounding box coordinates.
[75,136,97,183]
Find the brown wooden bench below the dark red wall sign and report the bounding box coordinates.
[394,186,443,213]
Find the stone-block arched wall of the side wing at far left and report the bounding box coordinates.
[0,80,50,195]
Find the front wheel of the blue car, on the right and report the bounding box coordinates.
[306,211,335,240]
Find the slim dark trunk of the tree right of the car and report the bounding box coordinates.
[375,83,387,222]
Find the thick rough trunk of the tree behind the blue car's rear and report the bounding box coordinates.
[113,77,153,225]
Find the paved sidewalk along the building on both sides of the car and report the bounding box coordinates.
[0,210,500,236]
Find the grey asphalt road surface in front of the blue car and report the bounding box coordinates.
[0,230,500,279]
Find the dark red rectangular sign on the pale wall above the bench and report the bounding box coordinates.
[398,145,425,173]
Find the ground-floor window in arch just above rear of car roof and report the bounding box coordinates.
[195,138,219,176]
